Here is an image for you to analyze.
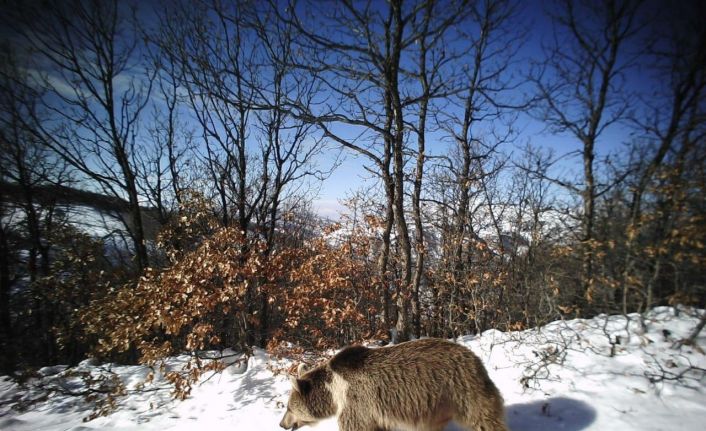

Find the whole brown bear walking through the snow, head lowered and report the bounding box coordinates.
[280,339,507,431]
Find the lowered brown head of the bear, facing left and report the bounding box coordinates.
[279,367,336,430]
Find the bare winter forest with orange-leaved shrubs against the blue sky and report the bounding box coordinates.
[0,0,706,398]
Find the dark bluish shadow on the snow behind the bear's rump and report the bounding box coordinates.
[505,397,596,431]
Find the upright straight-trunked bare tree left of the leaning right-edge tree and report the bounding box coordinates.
[531,0,640,306]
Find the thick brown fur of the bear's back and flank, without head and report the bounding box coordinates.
[328,339,499,427]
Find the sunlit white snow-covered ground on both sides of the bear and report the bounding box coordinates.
[0,307,706,431]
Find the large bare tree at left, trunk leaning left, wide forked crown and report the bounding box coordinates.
[8,0,153,271]
